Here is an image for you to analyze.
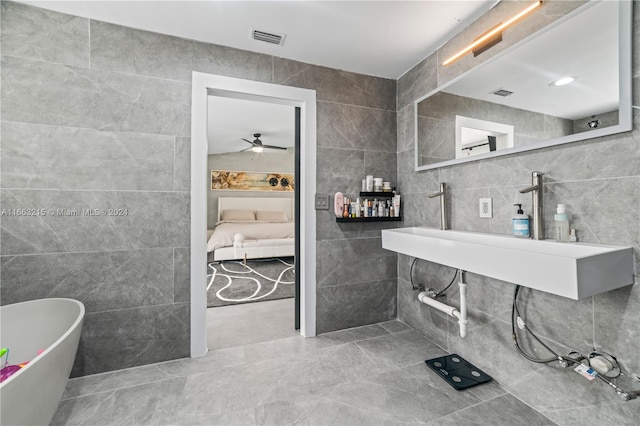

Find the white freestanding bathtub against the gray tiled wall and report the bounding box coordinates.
[0,299,84,426]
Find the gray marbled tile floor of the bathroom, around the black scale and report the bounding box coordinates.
[52,312,554,426]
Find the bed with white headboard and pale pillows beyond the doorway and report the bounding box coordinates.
[207,197,295,261]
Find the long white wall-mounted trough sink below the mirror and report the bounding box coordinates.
[382,227,633,300]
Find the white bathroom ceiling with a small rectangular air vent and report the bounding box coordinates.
[23,0,497,79]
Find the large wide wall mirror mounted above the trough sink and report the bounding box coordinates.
[414,1,632,170]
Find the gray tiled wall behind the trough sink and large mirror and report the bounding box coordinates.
[398,2,640,424]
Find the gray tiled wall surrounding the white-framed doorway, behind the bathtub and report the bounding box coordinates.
[0,1,397,376]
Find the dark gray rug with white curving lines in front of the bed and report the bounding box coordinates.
[207,257,295,308]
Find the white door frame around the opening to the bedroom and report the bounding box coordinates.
[190,71,316,358]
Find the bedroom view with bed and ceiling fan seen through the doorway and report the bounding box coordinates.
[206,95,300,350]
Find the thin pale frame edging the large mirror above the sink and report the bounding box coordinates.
[413,1,633,171]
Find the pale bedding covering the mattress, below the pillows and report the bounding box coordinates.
[207,221,295,252]
